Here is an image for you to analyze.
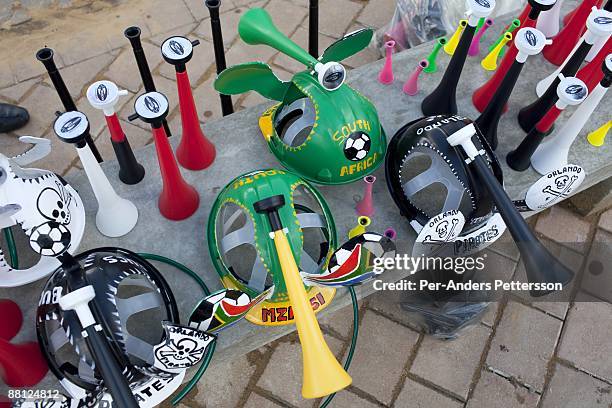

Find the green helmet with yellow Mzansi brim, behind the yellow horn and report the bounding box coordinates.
[208,169,336,325]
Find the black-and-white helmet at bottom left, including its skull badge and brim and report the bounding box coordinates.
[36,248,215,407]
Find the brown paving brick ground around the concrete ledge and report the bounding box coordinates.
[0,0,612,408]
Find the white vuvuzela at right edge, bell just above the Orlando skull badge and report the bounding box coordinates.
[531,57,612,174]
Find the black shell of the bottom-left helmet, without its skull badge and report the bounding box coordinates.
[36,248,184,406]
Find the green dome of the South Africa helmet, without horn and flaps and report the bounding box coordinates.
[259,71,387,184]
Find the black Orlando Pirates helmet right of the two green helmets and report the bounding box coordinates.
[385,115,505,254]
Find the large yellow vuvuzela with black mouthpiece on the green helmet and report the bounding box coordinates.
[253,195,353,398]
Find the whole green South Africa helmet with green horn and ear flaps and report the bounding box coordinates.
[215,8,386,184]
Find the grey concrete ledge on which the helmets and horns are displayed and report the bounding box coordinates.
[0,3,612,392]
